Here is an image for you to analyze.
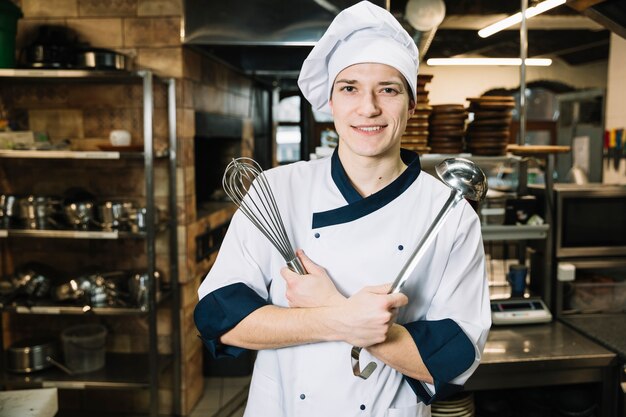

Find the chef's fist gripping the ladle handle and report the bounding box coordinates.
[334,284,409,347]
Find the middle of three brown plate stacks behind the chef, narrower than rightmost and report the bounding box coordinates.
[428,104,467,153]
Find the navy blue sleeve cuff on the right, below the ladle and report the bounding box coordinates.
[403,319,475,404]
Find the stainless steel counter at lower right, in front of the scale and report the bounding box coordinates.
[465,321,618,417]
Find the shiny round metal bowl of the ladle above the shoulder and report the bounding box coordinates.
[435,158,487,201]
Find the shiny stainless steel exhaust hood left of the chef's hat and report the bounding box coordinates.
[183,0,386,88]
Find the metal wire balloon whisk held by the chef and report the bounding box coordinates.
[222,157,306,275]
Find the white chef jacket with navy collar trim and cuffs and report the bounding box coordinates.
[195,150,491,417]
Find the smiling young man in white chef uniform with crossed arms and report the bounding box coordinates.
[195,1,491,417]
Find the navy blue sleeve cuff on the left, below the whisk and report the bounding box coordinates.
[193,282,268,358]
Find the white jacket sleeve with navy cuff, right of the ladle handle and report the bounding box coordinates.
[404,211,491,404]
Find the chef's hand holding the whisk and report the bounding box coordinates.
[280,249,345,307]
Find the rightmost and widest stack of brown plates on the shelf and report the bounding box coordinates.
[465,96,515,155]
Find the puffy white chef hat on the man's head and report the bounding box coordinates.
[298,1,419,113]
